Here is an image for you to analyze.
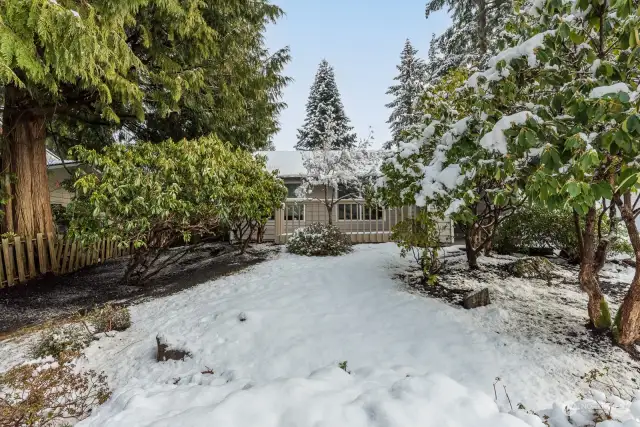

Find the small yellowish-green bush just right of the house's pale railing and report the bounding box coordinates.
[391,210,441,283]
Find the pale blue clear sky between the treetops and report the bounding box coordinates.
[267,0,450,150]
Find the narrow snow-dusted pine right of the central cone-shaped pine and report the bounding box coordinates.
[385,39,426,149]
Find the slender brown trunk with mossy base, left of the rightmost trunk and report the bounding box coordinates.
[578,207,611,329]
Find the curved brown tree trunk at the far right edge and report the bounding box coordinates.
[616,193,640,345]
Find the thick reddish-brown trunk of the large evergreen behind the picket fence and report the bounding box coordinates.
[2,85,54,236]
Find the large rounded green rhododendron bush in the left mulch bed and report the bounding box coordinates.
[67,136,287,284]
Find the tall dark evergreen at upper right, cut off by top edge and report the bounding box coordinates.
[425,0,512,79]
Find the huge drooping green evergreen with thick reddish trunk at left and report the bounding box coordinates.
[0,0,288,235]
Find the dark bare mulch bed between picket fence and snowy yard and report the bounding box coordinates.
[0,244,278,337]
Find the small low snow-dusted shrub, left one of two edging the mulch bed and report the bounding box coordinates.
[31,325,93,359]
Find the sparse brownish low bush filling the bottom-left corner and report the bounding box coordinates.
[0,354,111,427]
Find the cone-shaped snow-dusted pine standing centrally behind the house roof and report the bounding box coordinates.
[296,60,356,150]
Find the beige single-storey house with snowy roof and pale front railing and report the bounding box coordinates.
[258,151,454,243]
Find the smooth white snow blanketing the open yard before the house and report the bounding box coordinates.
[0,243,637,427]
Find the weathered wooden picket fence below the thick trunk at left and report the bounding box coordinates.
[0,233,132,288]
